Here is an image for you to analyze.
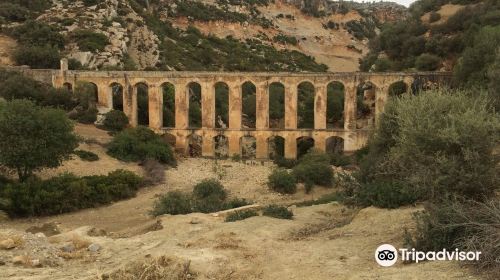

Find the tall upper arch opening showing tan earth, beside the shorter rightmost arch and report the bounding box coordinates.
[356,81,376,128]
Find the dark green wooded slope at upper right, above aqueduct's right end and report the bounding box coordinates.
[360,0,500,86]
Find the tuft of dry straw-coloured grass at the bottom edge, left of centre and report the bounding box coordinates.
[104,256,196,280]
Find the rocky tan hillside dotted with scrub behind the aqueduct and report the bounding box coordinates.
[0,0,406,71]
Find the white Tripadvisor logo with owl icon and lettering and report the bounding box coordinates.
[375,244,481,266]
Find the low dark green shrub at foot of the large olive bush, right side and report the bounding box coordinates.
[356,181,421,208]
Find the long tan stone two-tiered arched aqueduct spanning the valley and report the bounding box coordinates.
[52,60,450,158]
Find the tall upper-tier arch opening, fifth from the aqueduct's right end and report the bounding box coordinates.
[269,82,285,129]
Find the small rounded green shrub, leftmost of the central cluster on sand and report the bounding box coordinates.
[151,191,193,216]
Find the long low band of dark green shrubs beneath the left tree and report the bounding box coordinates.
[0,170,141,217]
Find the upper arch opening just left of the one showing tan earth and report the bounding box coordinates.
[326,82,345,128]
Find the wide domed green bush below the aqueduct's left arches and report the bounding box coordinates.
[108,126,176,165]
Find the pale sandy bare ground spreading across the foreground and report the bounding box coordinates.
[0,126,476,280]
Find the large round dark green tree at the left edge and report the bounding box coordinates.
[0,100,78,181]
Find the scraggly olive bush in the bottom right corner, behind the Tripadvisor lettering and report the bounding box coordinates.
[406,199,500,279]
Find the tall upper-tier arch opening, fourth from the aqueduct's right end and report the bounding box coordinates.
[297,82,315,128]
